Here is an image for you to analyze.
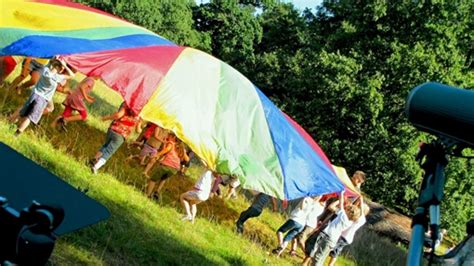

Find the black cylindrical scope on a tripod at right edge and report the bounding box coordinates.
[406,82,474,266]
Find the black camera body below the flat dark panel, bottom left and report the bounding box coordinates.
[0,196,64,265]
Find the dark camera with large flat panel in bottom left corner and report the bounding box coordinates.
[0,142,110,265]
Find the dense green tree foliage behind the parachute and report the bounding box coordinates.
[76,0,474,241]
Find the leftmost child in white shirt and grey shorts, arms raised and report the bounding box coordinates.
[10,59,74,136]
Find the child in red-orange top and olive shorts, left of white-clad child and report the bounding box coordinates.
[143,133,189,198]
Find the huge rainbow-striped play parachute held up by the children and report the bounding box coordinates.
[0,0,360,199]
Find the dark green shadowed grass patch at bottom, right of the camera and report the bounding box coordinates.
[51,194,225,265]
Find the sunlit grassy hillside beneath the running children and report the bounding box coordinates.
[0,71,404,265]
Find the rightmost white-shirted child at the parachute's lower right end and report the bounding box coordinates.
[329,197,370,266]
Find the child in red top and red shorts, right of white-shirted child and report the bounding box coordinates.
[51,77,97,131]
